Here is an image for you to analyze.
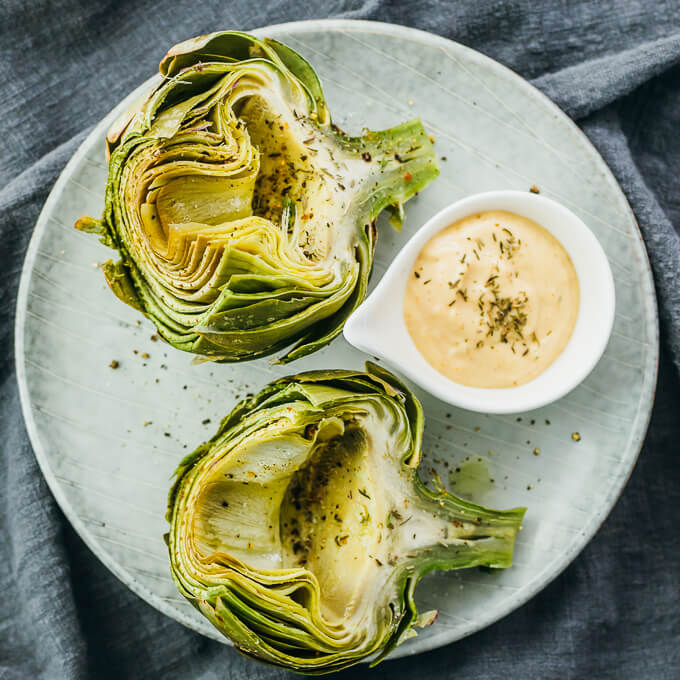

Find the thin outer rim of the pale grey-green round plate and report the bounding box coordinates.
[14,19,660,659]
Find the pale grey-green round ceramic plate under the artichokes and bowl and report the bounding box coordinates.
[16,21,658,656]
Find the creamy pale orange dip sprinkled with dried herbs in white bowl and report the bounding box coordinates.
[404,210,580,387]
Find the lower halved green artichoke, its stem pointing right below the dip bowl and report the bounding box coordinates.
[166,364,524,674]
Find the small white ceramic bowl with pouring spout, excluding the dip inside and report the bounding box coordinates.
[344,191,615,413]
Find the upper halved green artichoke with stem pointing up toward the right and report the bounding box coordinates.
[76,32,438,361]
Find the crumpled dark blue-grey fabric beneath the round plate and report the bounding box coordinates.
[0,0,680,680]
